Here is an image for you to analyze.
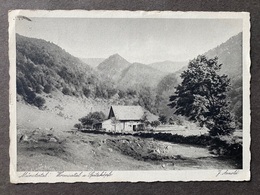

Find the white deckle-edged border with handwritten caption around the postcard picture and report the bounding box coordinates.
[9,10,251,183]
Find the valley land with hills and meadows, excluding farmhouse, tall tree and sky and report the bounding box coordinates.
[17,31,242,171]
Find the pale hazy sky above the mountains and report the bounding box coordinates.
[16,18,242,63]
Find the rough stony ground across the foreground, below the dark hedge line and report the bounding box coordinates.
[18,130,240,171]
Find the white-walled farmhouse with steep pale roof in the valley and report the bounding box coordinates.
[94,106,145,132]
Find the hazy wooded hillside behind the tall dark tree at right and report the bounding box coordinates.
[153,33,242,127]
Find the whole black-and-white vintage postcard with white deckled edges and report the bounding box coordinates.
[9,10,251,183]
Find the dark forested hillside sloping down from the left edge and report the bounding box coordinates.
[16,34,116,106]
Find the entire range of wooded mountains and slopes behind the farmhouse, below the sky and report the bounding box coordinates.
[16,33,242,125]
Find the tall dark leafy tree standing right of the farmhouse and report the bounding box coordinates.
[169,55,235,136]
